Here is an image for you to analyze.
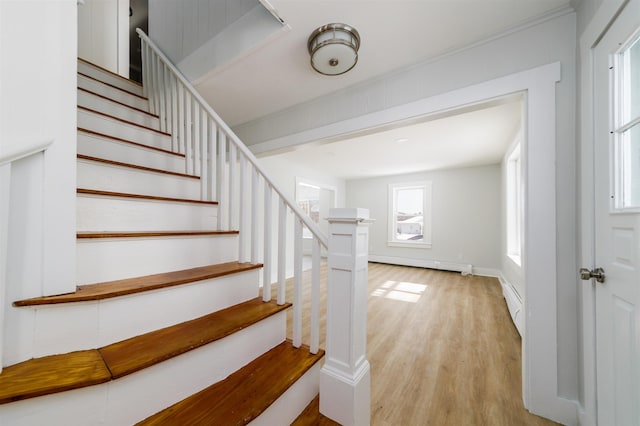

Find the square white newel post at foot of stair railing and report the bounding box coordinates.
[320,208,371,426]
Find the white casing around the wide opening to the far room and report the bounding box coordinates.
[251,62,577,424]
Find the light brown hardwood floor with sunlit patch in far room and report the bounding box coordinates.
[274,263,556,426]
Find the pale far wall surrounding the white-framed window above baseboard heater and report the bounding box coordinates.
[347,165,501,275]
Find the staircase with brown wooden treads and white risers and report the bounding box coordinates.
[0,60,323,426]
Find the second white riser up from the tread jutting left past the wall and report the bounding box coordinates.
[76,194,217,231]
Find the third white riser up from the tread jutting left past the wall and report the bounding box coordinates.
[77,160,200,200]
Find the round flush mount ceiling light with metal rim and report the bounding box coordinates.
[307,24,360,75]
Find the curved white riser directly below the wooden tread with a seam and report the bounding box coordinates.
[0,312,286,426]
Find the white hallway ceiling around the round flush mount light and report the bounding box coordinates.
[195,0,569,127]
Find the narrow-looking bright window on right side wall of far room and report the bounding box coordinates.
[507,143,522,265]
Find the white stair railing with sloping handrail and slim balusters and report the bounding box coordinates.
[137,29,328,354]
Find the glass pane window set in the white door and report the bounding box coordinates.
[612,30,640,211]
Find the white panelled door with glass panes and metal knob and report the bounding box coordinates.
[583,0,640,426]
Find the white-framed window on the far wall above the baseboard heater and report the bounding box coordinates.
[388,182,431,248]
